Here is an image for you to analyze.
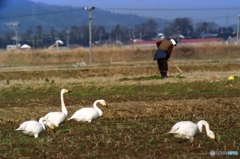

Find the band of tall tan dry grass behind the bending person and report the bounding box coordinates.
[0,44,240,66]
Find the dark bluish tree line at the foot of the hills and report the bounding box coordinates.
[0,18,234,48]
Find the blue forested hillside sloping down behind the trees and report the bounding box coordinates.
[0,0,164,32]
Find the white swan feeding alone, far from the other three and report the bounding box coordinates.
[169,120,216,141]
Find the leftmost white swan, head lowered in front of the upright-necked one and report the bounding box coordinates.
[16,117,54,138]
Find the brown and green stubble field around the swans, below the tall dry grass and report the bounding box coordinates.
[0,45,240,159]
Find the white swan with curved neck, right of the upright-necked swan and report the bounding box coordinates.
[68,99,107,122]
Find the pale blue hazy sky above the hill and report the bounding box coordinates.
[31,0,240,26]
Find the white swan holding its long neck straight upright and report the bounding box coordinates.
[44,89,71,127]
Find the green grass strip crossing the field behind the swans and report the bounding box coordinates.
[0,77,240,101]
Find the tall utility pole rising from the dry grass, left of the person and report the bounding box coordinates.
[85,7,95,64]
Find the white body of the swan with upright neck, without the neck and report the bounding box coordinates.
[44,112,67,127]
